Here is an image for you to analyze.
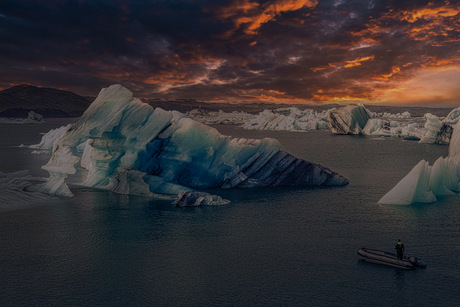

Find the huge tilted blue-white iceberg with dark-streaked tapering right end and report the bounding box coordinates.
[40,85,348,196]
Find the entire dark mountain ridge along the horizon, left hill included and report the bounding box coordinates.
[0,84,451,118]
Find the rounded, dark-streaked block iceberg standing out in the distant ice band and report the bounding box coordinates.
[327,104,372,134]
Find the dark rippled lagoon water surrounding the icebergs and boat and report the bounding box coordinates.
[0,121,460,306]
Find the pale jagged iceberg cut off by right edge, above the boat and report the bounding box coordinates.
[378,121,460,205]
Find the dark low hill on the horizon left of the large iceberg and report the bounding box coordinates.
[0,84,93,118]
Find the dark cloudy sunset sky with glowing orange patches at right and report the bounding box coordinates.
[0,0,460,106]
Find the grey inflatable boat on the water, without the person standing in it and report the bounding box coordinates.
[358,247,426,270]
